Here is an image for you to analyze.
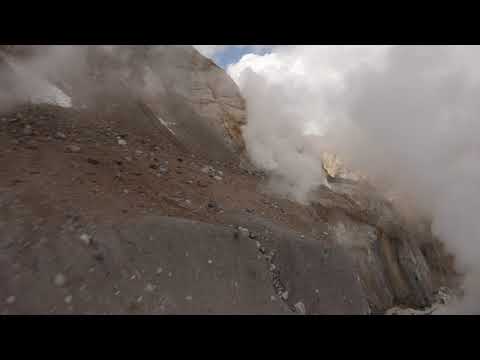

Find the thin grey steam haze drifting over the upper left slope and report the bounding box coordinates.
[0,45,170,110]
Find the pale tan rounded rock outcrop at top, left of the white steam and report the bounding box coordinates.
[135,46,246,160]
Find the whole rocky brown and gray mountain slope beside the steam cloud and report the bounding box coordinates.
[0,46,453,314]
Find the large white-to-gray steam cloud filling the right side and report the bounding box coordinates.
[228,46,480,313]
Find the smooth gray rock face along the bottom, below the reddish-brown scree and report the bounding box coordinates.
[0,210,368,314]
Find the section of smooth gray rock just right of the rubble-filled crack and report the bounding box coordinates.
[219,213,370,315]
